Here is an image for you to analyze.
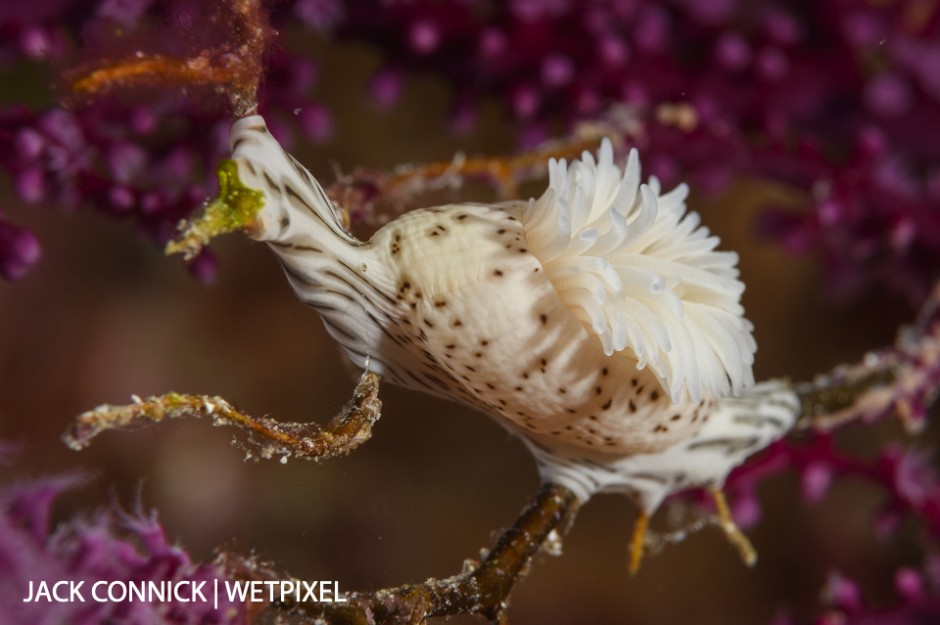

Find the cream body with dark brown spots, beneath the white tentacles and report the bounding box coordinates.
[358,204,704,454]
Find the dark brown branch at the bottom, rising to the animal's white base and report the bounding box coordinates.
[276,484,578,625]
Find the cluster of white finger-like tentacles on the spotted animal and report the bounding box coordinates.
[523,139,757,402]
